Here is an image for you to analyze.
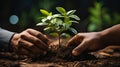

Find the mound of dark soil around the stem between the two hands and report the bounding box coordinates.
[32,39,96,62]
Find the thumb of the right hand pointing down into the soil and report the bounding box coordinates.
[72,41,89,56]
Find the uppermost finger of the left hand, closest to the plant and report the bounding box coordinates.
[27,29,50,44]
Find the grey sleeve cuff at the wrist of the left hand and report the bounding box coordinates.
[0,28,14,51]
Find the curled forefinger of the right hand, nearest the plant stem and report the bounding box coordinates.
[67,35,83,46]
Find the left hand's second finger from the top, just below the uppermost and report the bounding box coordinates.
[21,33,48,50]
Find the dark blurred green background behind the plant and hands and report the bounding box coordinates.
[0,0,120,32]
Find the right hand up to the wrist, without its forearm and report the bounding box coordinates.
[67,32,106,56]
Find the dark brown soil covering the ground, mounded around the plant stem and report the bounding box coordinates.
[0,39,120,67]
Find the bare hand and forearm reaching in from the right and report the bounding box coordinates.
[67,24,120,56]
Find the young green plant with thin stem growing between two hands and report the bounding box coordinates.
[37,7,80,46]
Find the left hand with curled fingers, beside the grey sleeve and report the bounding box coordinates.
[11,29,50,57]
